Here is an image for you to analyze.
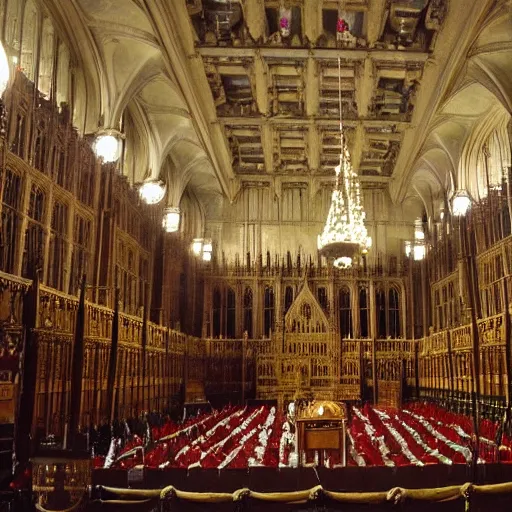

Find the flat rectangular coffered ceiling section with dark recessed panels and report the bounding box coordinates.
[182,0,445,184]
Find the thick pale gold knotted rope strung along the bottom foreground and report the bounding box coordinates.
[97,482,512,504]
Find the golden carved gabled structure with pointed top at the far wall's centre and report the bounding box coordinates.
[256,281,343,407]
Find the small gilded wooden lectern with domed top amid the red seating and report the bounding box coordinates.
[296,401,347,466]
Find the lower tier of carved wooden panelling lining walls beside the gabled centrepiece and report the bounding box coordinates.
[4,275,507,442]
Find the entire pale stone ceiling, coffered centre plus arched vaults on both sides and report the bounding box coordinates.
[43,0,512,226]
